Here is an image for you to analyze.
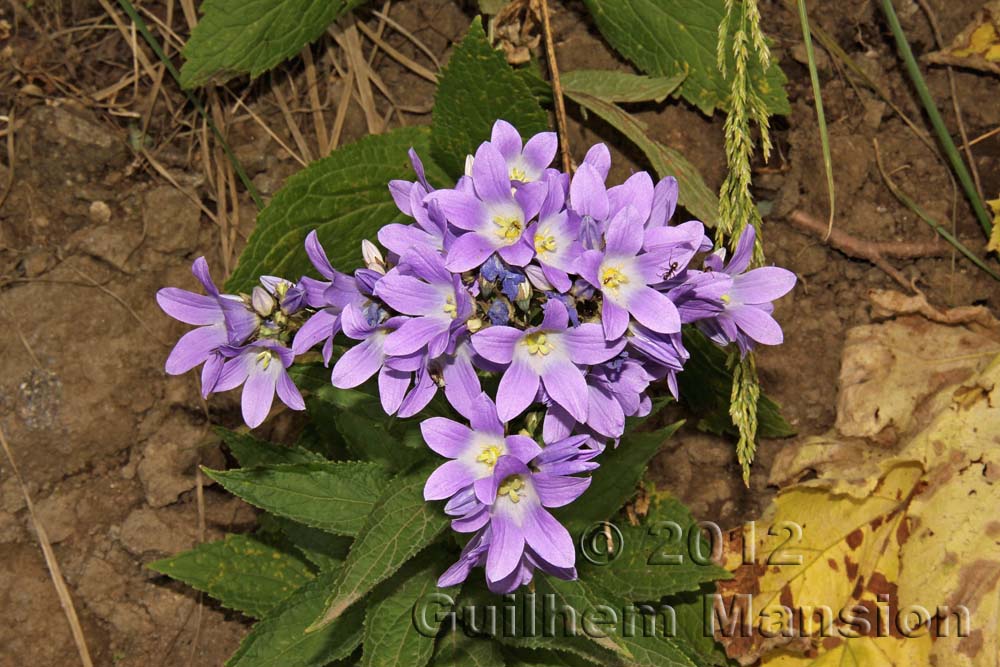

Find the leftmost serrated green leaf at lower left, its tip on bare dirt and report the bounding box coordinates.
[149,535,313,618]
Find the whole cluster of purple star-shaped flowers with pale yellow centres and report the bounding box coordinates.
[158,121,795,592]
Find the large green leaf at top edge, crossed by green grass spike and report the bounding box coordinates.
[584,0,790,114]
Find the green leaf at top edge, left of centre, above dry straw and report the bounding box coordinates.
[181,0,363,88]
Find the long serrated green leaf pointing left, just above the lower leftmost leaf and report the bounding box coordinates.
[205,461,389,535]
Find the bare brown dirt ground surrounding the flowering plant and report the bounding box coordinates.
[0,0,1000,667]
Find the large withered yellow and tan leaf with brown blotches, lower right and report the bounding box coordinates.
[716,317,1000,667]
